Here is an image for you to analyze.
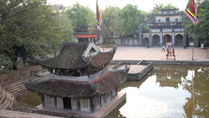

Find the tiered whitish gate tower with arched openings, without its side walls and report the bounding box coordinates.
[141,9,186,47]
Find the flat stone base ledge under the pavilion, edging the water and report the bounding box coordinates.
[33,92,126,118]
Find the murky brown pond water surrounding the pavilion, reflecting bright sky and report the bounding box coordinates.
[17,65,209,118]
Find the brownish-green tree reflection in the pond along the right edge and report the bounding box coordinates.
[183,67,209,117]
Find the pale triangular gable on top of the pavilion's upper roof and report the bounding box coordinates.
[82,41,100,62]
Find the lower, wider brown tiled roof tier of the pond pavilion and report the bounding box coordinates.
[25,68,129,98]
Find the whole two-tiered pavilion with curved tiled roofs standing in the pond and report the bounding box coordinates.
[25,41,129,117]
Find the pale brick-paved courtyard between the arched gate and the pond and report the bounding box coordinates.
[100,46,209,61]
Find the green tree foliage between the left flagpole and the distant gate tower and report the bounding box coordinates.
[102,4,149,40]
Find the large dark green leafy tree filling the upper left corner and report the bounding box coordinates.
[0,0,72,69]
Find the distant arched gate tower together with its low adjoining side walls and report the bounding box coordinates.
[114,8,198,47]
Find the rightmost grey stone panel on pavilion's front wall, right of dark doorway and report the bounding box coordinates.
[79,99,91,112]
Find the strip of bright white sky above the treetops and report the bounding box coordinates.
[47,0,187,12]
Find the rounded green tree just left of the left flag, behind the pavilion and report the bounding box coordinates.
[66,3,96,32]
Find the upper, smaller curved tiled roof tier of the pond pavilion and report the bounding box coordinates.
[39,43,116,69]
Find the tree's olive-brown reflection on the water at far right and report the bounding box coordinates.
[183,67,209,118]
